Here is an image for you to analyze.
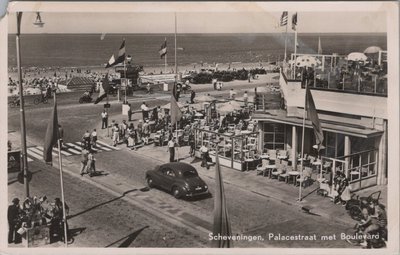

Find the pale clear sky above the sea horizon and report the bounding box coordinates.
[8,5,387,33]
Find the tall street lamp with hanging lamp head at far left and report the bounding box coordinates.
[16,12,44,197]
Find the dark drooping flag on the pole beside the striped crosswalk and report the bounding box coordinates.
[43,101,59,162]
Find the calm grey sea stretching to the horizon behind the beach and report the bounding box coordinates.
[8,33,387,68]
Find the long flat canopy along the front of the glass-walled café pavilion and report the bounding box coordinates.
[252,110,383,138]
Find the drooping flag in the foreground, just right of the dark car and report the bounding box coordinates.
[212,153,233,248]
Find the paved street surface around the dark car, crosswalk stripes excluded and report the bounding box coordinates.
[8,81,352,247]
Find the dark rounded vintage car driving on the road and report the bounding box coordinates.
[146,162,209,198]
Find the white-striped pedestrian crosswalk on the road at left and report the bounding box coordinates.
[27,140,120,162]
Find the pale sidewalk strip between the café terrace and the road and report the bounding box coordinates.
[126,142,387,225]
